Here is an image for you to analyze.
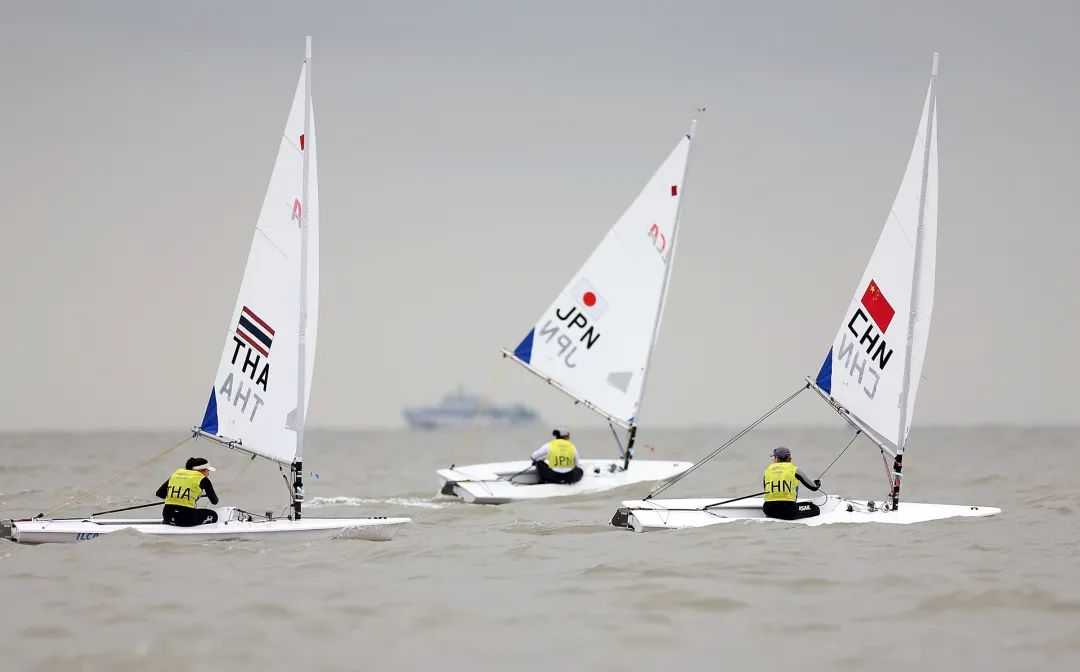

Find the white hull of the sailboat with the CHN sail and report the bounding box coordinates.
[611,495,1001,532]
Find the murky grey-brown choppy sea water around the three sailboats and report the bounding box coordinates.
[0,429,1080,672]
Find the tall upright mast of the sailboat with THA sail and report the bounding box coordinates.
[292,35,315,520]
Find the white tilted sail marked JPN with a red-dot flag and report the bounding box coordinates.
[512,131,692,427]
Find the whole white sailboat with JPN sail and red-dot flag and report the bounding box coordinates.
[437,122,696,503]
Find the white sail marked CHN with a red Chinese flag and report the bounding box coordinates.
[815,68,937,448]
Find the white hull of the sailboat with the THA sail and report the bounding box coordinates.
[11,508,411,543]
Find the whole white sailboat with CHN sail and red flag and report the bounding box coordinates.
[611,54,1001,532]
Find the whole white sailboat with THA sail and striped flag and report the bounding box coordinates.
[5,37,409,543]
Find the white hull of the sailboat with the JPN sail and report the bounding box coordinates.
[437,459,693,505]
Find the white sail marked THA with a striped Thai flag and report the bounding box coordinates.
[200,69,319,463]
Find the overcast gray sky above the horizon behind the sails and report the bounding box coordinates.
[0,1,1080,429]
